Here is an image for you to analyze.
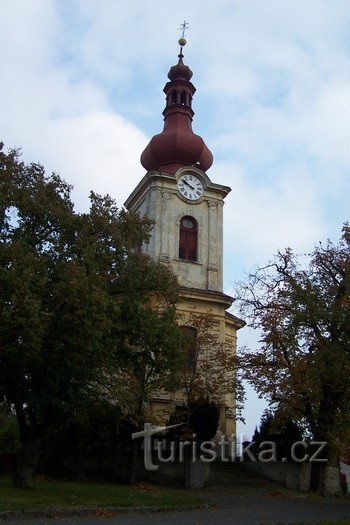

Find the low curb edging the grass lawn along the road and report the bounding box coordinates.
[0,501,217,522]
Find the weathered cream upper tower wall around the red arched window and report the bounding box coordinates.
[130,168,223,291]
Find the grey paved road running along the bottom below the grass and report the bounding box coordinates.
[4,485,350,525]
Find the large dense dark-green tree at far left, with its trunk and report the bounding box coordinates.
[0,145,177,487]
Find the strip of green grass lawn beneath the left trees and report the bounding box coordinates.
[0,476,205,511]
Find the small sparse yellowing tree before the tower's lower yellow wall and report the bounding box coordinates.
[163,311,243,487]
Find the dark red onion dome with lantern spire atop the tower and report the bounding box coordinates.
[141,43,213,174]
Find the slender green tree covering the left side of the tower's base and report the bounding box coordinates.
[105,254,183,483]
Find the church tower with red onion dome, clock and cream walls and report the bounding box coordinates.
[125,38,244,434]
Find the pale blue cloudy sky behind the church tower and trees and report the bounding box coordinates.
[0,0,350,438]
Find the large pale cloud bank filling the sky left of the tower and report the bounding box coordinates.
[0,1,147,208]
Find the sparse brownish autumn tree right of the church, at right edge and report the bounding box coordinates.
[239,224,350,494]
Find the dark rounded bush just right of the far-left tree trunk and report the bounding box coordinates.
[37,400,138,481]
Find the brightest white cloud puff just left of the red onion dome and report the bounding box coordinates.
[27,110,145,209]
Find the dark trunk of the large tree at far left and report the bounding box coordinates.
[13,434,40,489]
